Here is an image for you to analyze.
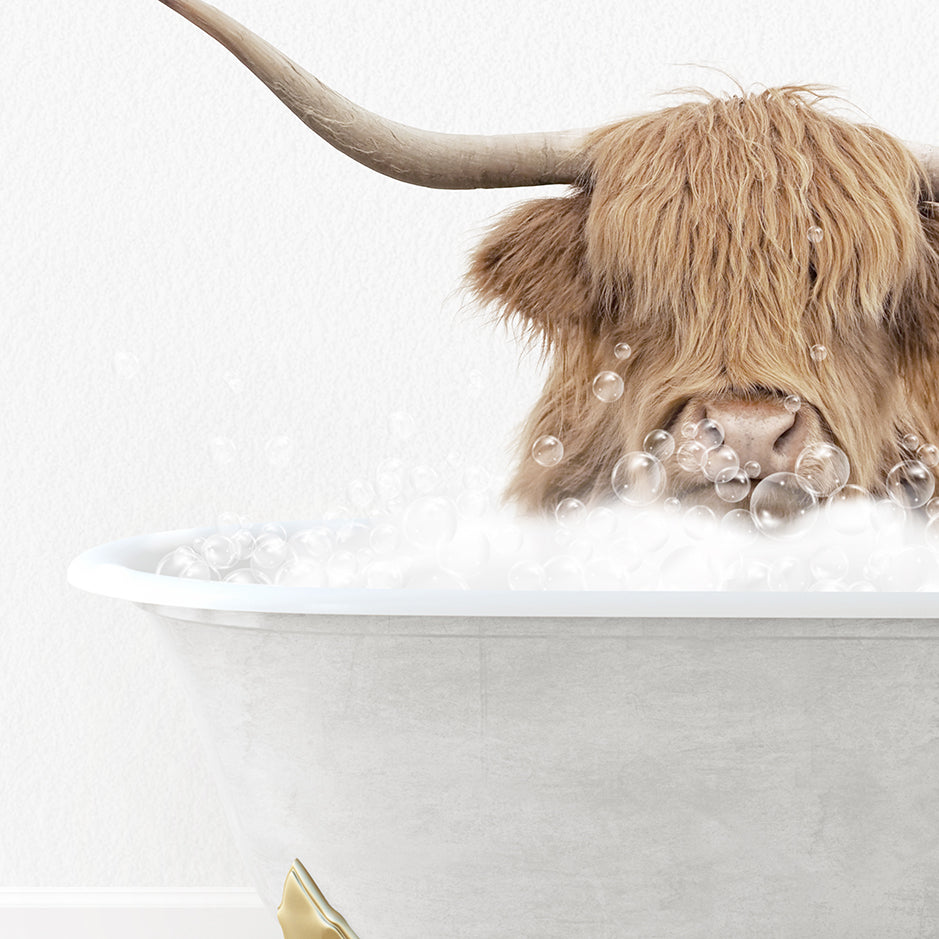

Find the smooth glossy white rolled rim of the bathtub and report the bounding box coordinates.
[67,522,939,620]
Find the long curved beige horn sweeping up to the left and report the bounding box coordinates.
[161,0,589,189]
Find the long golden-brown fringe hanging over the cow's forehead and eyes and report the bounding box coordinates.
[587,85,931,342]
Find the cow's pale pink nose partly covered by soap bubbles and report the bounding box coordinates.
[704,398,807,476]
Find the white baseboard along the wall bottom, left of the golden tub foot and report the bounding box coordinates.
[0,890,283,939]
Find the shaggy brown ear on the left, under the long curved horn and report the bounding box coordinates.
[466,191,596,346]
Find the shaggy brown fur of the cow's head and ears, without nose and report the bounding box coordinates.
[468,86,939,510]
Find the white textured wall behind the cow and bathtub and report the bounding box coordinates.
[0,0,939,889]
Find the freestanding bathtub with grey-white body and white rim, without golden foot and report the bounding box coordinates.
[69,526,939,939]
